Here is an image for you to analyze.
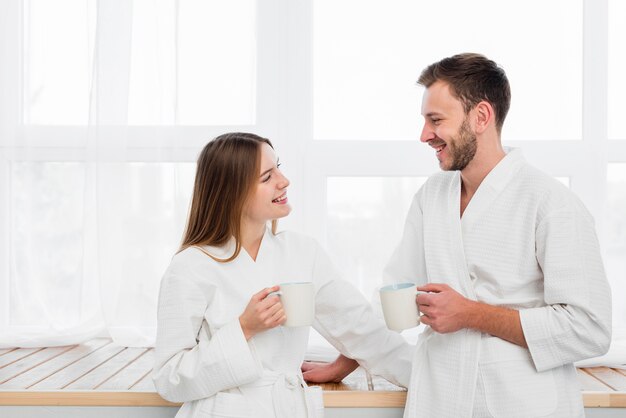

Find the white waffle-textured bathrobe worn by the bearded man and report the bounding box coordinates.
[384,150,611,418]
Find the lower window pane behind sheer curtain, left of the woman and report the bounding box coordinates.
[9,162,195,327]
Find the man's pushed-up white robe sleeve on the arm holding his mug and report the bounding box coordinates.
[520,197,611,371]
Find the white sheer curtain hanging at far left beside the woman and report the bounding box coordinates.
[0,0,196,347]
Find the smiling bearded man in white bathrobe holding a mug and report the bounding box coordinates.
[303,54,611,418]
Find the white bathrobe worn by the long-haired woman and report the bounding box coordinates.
[153,230,414,418]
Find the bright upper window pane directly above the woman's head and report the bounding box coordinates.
[129,0,256,125]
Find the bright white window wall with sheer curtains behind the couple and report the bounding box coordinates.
[0,0,626,346]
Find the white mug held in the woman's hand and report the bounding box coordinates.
[273,282,315,327]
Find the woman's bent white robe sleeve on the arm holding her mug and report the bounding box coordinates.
[153,270,262,402]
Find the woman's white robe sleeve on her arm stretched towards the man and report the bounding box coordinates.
[313,246,415,387]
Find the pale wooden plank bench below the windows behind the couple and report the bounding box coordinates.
[0,338,626,415]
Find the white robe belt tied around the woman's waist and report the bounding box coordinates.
[241,370,317,418]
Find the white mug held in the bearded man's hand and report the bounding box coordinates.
[379,283,422,331]
